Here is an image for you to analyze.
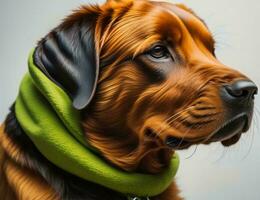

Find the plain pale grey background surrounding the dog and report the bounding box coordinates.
[0,0,260,200]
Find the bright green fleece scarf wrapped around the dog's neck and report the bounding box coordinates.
[15,51,179,197]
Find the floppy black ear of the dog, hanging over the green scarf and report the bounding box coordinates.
[34,7,99,110]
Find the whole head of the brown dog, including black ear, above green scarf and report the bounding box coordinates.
[34,0,257,173]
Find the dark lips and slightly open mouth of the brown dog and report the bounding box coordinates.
[166,113,251,150]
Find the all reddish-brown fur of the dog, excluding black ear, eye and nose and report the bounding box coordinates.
[0,0,250,200]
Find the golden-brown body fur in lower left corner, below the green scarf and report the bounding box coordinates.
[0,125,58,200]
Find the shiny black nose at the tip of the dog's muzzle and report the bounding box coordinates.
[223,80,257,103]
